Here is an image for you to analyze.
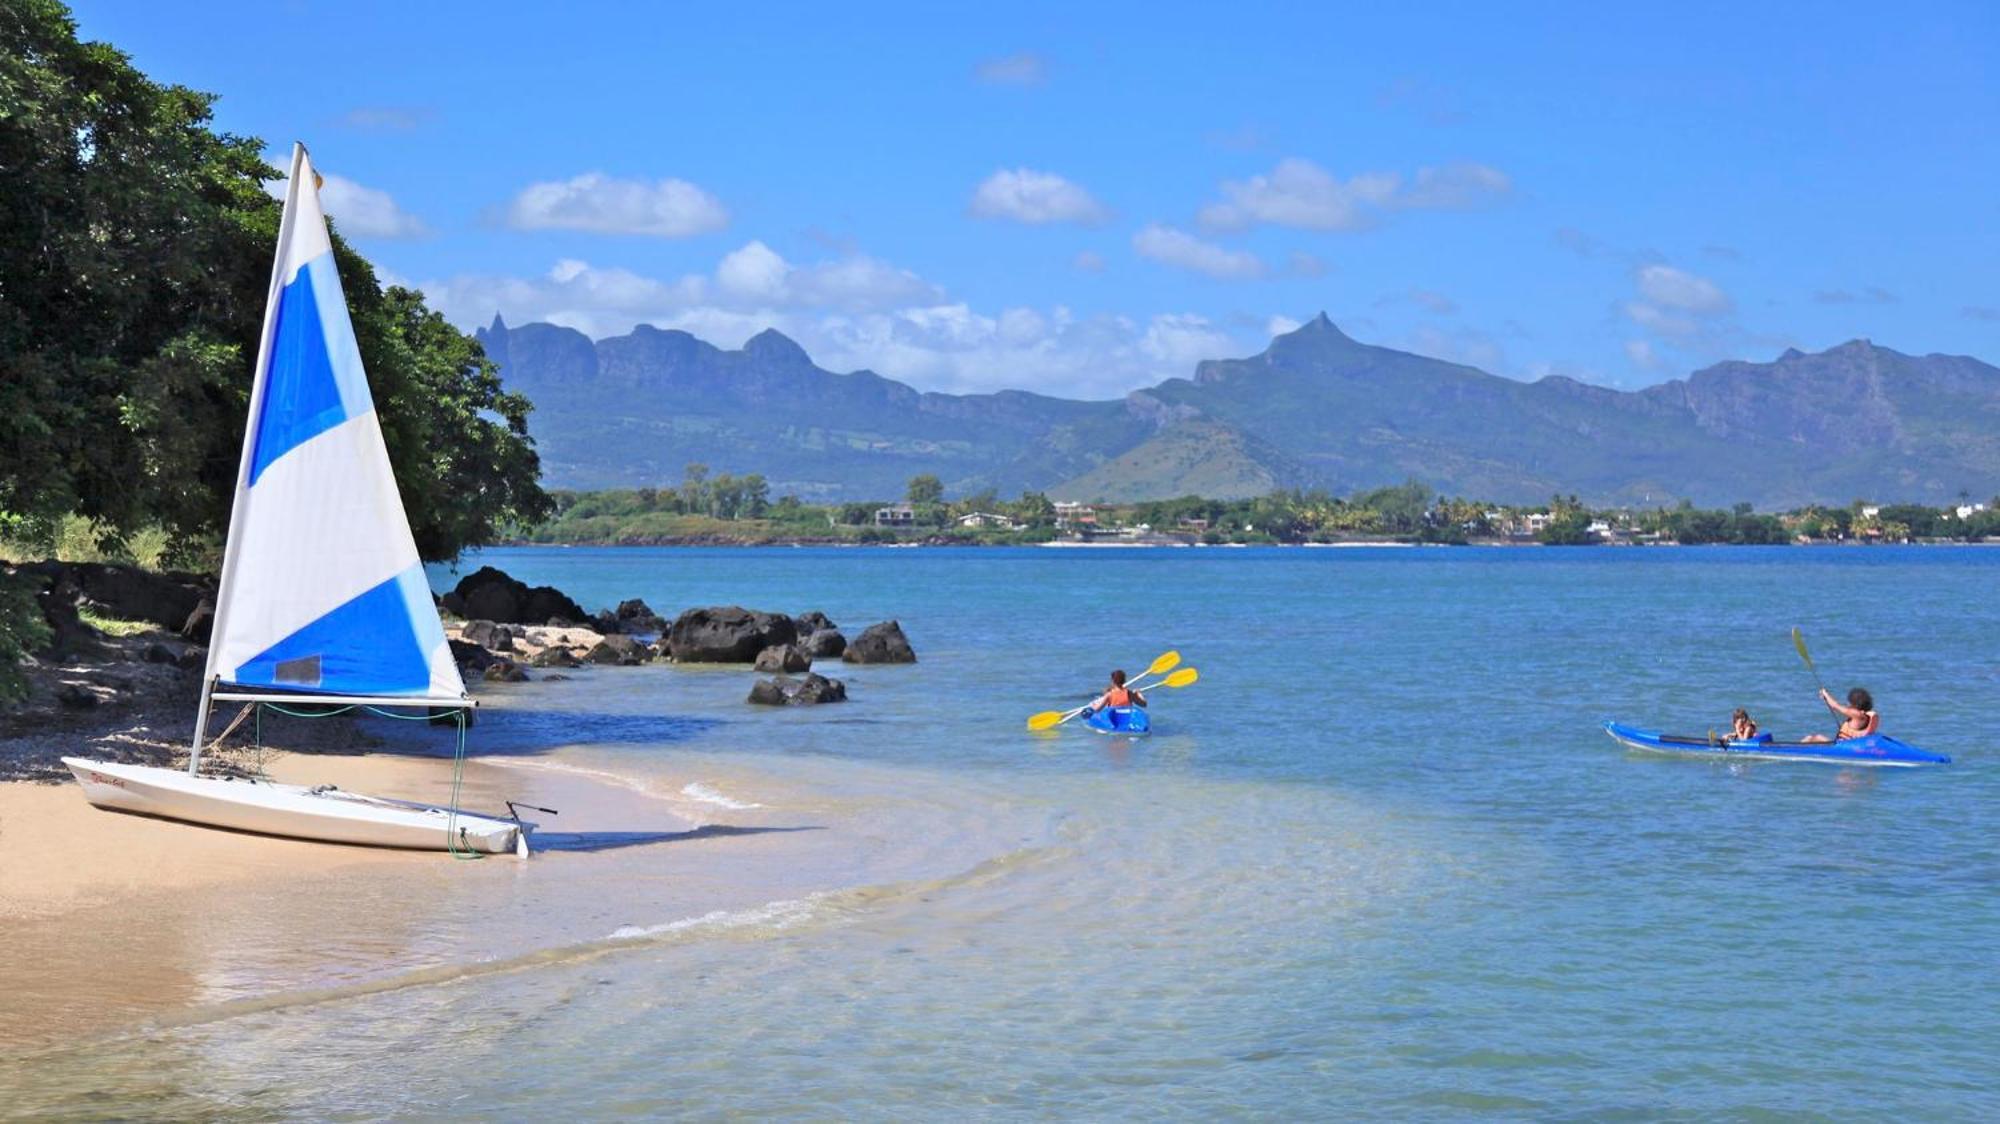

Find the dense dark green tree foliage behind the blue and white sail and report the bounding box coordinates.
[0,0,548,560]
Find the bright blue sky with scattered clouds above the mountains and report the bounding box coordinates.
[76,0,2000,396]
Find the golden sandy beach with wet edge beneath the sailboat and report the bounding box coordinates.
[0,754,836,1054]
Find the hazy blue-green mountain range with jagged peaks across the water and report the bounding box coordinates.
[476,314,2000,508]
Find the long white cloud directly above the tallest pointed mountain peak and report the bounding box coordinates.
[1198,156,1514,230]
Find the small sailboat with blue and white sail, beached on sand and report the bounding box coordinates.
[62,144,528,856]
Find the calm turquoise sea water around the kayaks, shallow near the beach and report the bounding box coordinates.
[0,548,2000,1120]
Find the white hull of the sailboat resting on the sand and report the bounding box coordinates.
[62,758,528,856]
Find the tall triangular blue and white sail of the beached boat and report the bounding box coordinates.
[206,146,466,702]
